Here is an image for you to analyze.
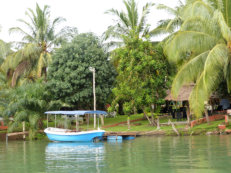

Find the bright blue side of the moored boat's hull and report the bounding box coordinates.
[46,132,105,142]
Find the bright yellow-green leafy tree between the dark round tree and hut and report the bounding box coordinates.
[110,32,168,125]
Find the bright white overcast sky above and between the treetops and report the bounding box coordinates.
[0,0,178,42]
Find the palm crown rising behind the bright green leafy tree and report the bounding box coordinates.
[103,0,154,45]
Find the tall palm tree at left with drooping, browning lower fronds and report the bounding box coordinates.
[2,4,67,86]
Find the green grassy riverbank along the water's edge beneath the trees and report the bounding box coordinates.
[0,114,231,140]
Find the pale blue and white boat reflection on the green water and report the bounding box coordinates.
[46,142,105,172]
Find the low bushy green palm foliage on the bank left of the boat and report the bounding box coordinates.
[0,81,62,137]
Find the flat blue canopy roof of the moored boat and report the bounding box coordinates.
[45,110,107,115]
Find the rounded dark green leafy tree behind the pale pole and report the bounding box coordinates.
[48,33,115,109]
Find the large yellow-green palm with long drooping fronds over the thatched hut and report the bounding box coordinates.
[164,0,231,116]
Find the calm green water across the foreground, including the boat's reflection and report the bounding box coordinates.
[0,136,231,173]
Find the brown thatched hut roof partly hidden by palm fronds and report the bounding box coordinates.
[165,84,195,101]
